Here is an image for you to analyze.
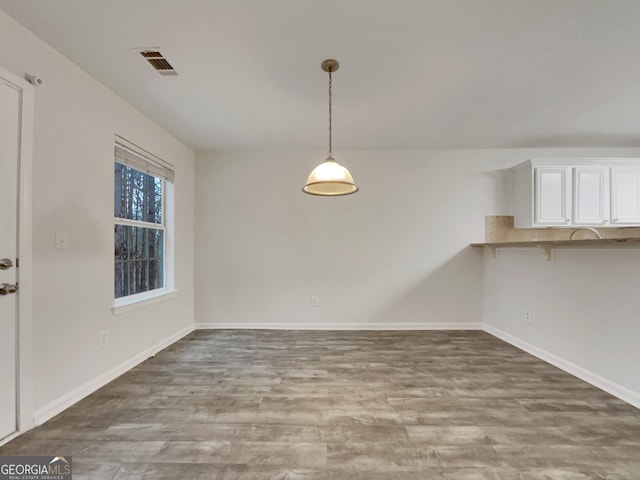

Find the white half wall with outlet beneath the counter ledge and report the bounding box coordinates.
[484,249,640,408]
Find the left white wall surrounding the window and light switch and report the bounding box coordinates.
[0,12,194,421]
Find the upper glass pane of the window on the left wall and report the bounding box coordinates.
[114,162,163,223]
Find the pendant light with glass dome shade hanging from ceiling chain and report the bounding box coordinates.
[302,60,358,197]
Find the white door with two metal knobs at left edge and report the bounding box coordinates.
[0,71,22,439]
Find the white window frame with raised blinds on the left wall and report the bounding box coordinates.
[111,135,176,315]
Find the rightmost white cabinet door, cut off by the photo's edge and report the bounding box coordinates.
[611,167,640,225]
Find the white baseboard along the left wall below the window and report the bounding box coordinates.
[33,326,194,425]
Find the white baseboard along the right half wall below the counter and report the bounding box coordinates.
[484,324,640,408]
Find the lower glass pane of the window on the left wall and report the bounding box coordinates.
[115,225,164,298]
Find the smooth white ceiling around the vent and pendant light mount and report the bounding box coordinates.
[0,0,640,151]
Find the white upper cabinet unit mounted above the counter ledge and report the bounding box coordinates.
[511,158,640,228]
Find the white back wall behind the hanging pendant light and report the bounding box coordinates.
[196,151,515,328]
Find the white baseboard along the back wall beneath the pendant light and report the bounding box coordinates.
[196,322,483,330]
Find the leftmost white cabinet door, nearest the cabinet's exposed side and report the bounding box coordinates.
[534,167,571,226]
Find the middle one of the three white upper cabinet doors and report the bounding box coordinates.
[572,167,609,225]
